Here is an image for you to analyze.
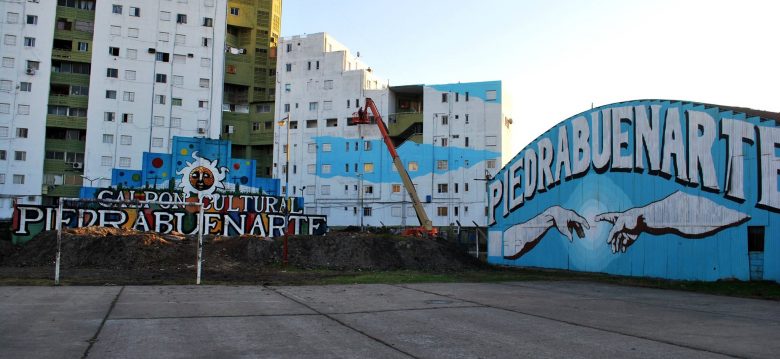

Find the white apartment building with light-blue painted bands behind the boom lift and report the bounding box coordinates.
[274,33,512,226]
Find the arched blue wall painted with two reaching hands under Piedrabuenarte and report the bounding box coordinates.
[488,100,780,281]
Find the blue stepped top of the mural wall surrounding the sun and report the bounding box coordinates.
[105,137,279,195]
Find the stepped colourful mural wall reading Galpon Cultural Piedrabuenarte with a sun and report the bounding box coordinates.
[12,137,327,243]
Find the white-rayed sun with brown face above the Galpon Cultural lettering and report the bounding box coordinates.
[176,151,228,199]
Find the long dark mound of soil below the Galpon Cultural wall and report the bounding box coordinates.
[0,227,480,281]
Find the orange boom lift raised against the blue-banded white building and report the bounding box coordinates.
[352,98,439,237]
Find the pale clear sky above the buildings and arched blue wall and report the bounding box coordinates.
[282,0,780,150]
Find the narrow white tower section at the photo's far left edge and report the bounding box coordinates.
[0,0,56,218]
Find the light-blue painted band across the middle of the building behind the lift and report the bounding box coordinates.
[314,136,500,183]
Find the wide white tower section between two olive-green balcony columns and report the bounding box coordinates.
[84,0,227,186]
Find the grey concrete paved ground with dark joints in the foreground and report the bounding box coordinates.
[0,282,780,358]
